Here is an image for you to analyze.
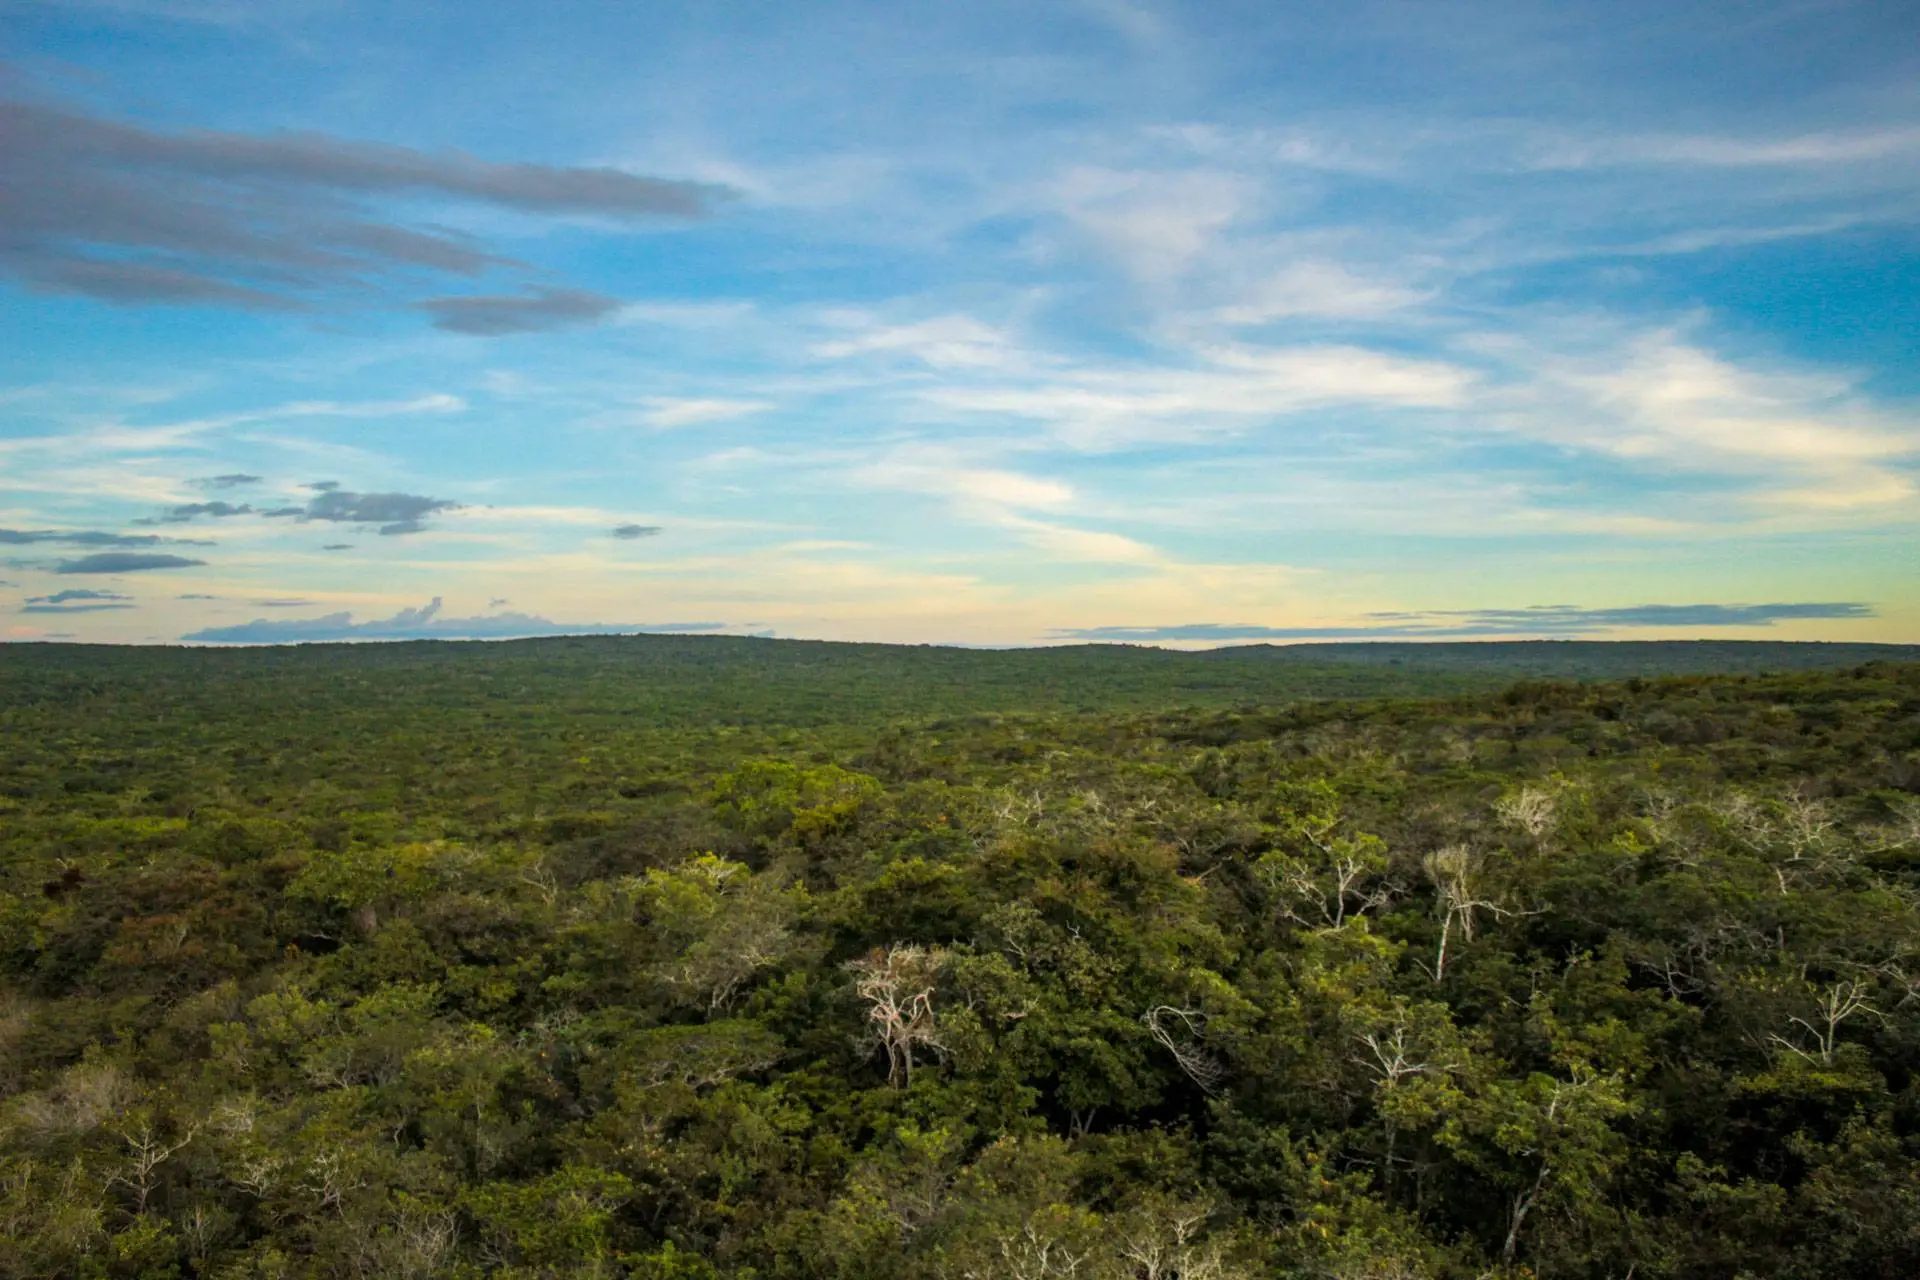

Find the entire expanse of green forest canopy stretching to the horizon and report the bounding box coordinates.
[0,637,1920,1280]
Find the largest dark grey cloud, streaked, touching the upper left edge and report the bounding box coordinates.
[0,102,730,311]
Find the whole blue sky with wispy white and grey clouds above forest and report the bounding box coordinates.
[0,0,1920,647]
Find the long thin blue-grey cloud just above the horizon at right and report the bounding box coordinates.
[1054,601,1878,643]
